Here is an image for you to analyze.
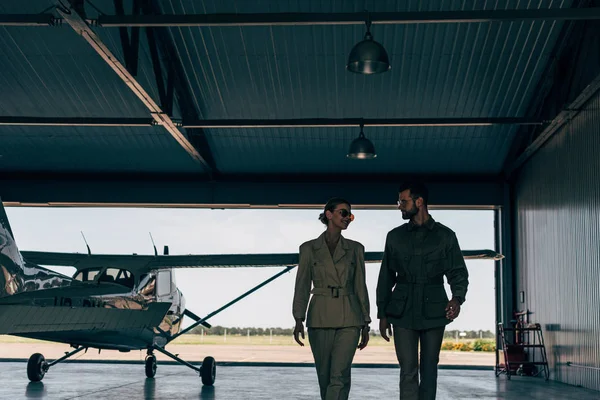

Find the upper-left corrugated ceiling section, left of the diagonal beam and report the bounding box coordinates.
[0,27,148,117]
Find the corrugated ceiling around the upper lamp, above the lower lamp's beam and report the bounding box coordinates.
[163,1,570,119]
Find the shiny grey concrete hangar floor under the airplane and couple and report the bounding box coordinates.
[0,362,600,400]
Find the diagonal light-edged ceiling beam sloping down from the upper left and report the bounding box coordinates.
[56,0,213,176]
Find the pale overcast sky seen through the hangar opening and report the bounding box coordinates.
[6,207,495,331]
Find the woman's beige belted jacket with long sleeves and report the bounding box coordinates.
[292,233,371,328]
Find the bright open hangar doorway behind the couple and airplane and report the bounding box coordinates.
[1,207,496,369]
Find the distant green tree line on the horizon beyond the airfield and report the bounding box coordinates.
[189,325,496,339]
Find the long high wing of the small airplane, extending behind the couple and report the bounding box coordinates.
[21,250,504,270]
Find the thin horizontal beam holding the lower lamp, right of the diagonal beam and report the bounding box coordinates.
[183,118,544,129]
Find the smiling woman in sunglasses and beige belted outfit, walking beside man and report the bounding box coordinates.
[292,198,371,400]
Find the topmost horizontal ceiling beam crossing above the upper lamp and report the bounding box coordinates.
[93,7,600,27]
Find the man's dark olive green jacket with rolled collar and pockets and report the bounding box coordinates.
[377,217,469,329]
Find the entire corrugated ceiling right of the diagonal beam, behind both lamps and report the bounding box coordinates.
[163,1,570,173]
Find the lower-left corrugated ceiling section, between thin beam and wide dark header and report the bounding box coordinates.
[0,126,202,173]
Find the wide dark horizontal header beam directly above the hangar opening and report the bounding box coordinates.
[0,171,504,208]
